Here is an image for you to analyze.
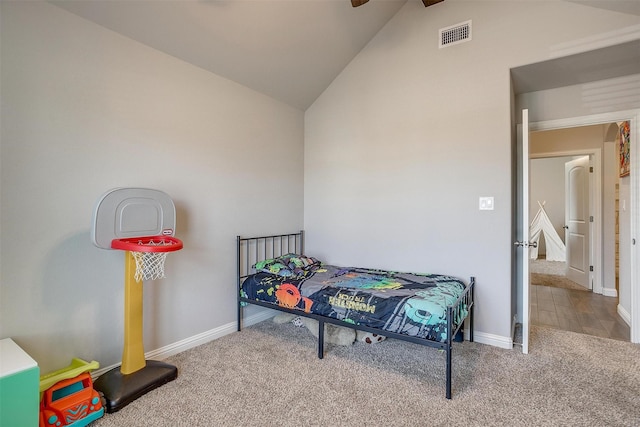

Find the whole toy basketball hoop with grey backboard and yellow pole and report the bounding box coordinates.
[91,188,182,412]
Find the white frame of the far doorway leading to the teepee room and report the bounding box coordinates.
[529,150,604,294]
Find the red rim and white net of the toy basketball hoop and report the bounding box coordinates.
[111,236,182,282]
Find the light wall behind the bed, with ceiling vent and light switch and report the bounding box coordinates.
[304,1,639,345]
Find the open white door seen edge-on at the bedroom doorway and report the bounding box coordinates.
[515,110,530,354]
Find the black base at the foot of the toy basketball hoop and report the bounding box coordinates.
[93,360,178,413]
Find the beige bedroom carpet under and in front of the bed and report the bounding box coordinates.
[93,321,640,427]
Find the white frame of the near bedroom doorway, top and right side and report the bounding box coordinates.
[523,109,640,343]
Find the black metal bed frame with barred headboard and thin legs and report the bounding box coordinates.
[236,231,475,399]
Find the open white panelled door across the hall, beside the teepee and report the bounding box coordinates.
[564,156,591,289]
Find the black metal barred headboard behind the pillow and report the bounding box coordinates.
[237,230,304,284]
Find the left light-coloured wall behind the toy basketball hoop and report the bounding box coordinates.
[0,2,304,373]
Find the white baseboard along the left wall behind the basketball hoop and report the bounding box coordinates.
[91,309,276,379]
